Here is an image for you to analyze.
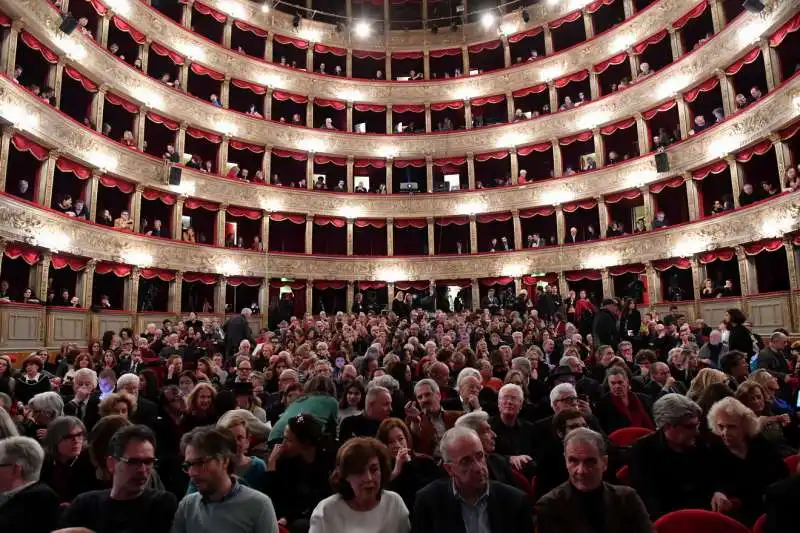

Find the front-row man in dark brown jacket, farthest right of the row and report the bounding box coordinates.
[536,428,655,533]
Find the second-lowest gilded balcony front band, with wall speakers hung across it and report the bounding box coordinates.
[0,71,800,218]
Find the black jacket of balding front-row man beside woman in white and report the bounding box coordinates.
[411,478,533,533]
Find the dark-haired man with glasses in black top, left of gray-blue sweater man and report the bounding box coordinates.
[61,425,178,533]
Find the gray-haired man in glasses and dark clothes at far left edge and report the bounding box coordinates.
[0,437,61,533]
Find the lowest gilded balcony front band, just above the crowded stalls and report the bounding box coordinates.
[0,193,800,281]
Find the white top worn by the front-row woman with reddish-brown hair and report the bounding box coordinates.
[309,490,411,533]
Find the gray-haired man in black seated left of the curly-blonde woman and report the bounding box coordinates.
[628,393,731,520]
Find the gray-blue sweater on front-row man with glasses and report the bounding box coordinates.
[172,483,278,533]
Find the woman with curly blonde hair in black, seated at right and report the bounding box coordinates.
[708,397,789,527]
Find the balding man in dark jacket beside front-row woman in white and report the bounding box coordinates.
[411,427,533,533]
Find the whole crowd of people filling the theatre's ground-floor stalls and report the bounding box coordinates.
[0,287,800,533]
